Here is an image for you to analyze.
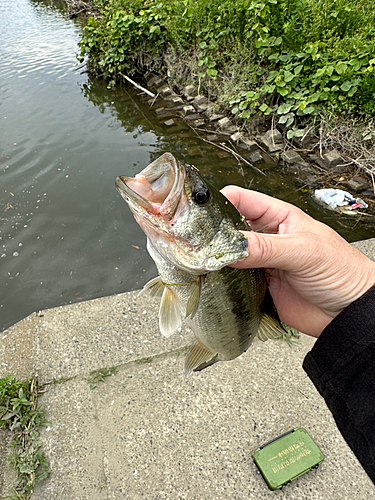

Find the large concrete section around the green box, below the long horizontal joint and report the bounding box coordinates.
[34,337,375,500]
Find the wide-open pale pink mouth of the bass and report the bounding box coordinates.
[115,153,185,219]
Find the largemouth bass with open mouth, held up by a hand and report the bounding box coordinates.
[116,153,283,374]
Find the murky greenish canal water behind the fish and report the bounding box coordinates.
[0,0,374,331]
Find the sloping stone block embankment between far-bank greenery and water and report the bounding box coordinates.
[140,73,375,201]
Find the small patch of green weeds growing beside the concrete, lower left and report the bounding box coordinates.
[0,375,49,500]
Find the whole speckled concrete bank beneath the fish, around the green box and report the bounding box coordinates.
[0,239,375,500]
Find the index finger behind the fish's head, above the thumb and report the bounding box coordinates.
[221,186,299,233]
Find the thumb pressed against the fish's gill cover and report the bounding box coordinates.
[230,231,309,270]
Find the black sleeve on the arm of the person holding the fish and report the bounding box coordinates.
[303,286,375,482]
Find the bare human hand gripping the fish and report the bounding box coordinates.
[222,186,375,337]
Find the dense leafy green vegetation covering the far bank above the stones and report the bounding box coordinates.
[80,0,375,133]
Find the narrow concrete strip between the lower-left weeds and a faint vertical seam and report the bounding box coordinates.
[33,379,107,500]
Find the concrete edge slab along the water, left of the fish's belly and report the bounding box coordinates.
[27,292,192,384]
